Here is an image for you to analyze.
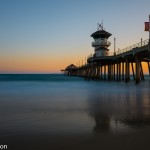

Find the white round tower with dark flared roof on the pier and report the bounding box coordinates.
[91,24,112,57]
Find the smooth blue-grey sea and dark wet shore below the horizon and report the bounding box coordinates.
[0,74,150,150]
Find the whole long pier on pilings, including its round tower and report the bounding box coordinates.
[62,25,150,84]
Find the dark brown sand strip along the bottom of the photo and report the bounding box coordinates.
[0,128,150,150]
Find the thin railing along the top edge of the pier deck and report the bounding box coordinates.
[87,39,149,59]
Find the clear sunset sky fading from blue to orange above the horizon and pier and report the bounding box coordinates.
[0,0,150,73]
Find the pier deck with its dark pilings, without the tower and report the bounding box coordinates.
[62,39,150,83]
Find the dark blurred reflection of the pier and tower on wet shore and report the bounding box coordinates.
[88,82,150,133]
